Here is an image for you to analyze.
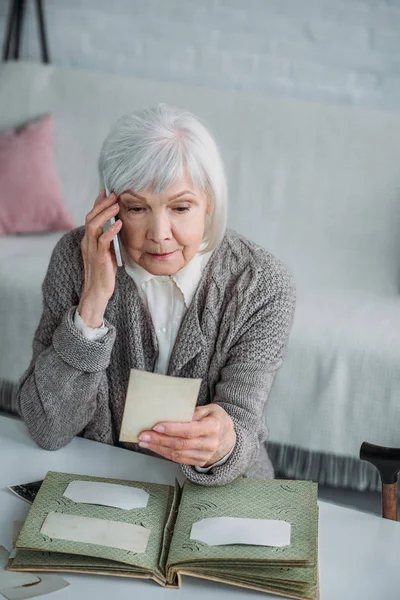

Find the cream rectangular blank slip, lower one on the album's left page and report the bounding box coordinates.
[40,512,150,553]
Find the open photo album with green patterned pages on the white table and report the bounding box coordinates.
[7,471,319,600]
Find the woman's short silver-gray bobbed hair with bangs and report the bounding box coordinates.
[98,104,228,253]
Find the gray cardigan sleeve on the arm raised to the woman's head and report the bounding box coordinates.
[17,231,116,450]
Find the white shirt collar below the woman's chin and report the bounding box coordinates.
[121,243,212,308]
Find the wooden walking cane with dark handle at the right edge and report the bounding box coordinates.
[360,442,400,521]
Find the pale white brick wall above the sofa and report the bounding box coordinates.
[0,0,400,110]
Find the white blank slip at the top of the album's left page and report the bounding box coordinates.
[63,480,149,510]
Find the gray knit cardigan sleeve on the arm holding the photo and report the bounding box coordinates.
[182,259,296,486]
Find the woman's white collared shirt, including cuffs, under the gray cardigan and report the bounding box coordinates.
[74,243,233,473]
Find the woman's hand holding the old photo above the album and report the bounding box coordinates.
[139,403,236,467]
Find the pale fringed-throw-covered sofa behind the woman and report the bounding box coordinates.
[0,62,400,490]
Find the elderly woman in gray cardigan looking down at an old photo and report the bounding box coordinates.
[17,105,295,485]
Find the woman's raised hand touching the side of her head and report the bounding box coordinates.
[78,189,122,327]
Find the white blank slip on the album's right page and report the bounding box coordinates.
[190,517,291,547]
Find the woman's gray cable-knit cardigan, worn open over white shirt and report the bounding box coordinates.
[17,227,296,485]
